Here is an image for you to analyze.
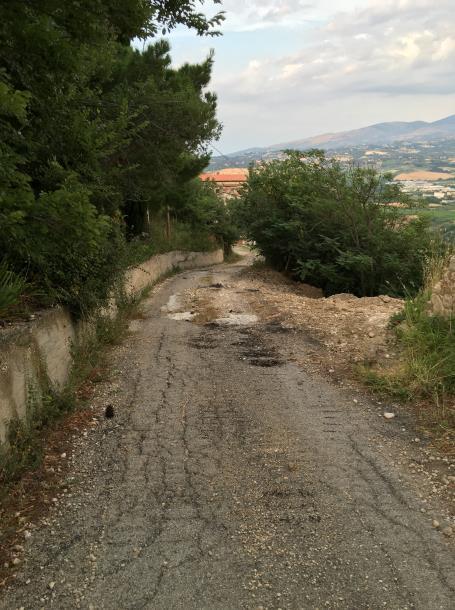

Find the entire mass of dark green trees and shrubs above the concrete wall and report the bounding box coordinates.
[0,0,232,317]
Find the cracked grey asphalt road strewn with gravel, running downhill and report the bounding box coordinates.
[0,253,455,610]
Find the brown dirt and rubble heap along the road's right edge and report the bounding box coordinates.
[241,268,403,372]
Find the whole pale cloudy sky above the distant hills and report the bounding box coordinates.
[166,0,455,153]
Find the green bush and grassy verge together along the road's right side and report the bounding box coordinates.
[237,151,455,445]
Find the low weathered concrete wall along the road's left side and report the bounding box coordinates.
[0,250,223,443]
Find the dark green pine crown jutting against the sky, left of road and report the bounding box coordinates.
[112,41,220,235]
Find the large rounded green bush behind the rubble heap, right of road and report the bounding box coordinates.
[237,151,431,296]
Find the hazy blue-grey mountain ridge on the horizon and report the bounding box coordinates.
[213,115,455,166]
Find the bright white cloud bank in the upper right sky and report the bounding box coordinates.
[218,0,455,102]
